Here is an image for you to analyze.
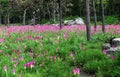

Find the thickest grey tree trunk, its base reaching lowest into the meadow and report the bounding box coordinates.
[86,0,91,41]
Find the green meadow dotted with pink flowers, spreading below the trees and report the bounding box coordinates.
[0,25,120,77]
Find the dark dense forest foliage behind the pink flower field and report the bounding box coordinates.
[0,0,120,24]
